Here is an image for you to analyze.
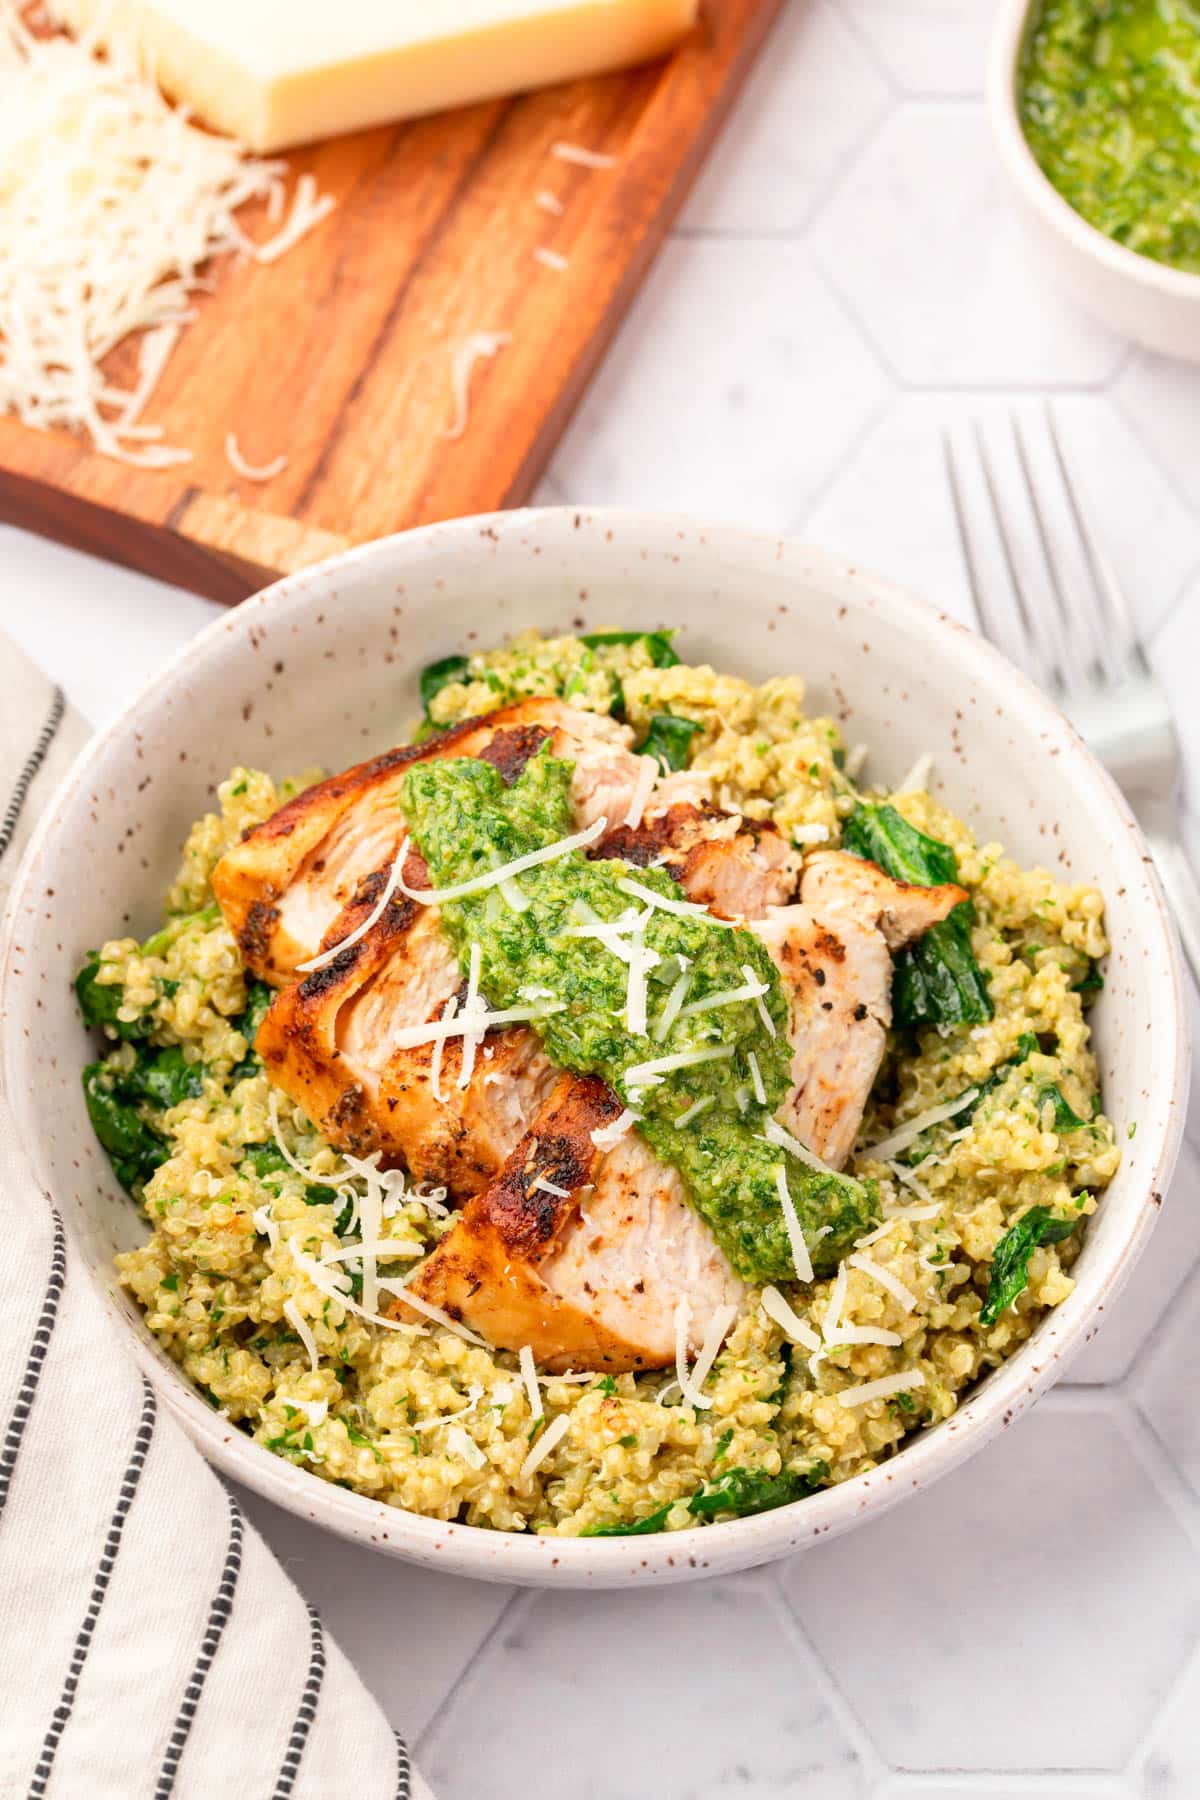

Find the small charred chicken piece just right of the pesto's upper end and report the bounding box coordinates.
[588,802,802,918]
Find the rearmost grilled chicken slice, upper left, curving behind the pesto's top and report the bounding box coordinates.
[212,698,669,986]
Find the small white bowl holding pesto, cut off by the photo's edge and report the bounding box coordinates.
[988,0,1200,362]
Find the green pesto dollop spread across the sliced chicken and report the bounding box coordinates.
[401,752,876,1282]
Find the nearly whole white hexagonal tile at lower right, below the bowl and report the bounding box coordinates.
[783,1399,1200,1771]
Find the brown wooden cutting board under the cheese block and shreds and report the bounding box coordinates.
[0,0,781,601]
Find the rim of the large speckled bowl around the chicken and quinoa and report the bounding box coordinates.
[0,506,1191,1588]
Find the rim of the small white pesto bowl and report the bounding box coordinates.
[986,0,1200,306]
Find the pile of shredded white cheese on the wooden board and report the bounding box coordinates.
[0,0,333,468]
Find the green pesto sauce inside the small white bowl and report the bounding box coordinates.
[1018,0,1200,272]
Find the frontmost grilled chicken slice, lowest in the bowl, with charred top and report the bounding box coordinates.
[392,1075,745,1370]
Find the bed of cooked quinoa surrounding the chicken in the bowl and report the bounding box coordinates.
[79,634,1119,1535]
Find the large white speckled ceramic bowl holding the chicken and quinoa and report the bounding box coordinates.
[0,509,1187,1586]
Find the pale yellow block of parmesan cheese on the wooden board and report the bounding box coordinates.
[52,0,700,151]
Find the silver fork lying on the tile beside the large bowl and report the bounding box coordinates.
[943,405,1200,983]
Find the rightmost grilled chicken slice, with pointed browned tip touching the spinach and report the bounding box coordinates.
[750,850,966,1168]
